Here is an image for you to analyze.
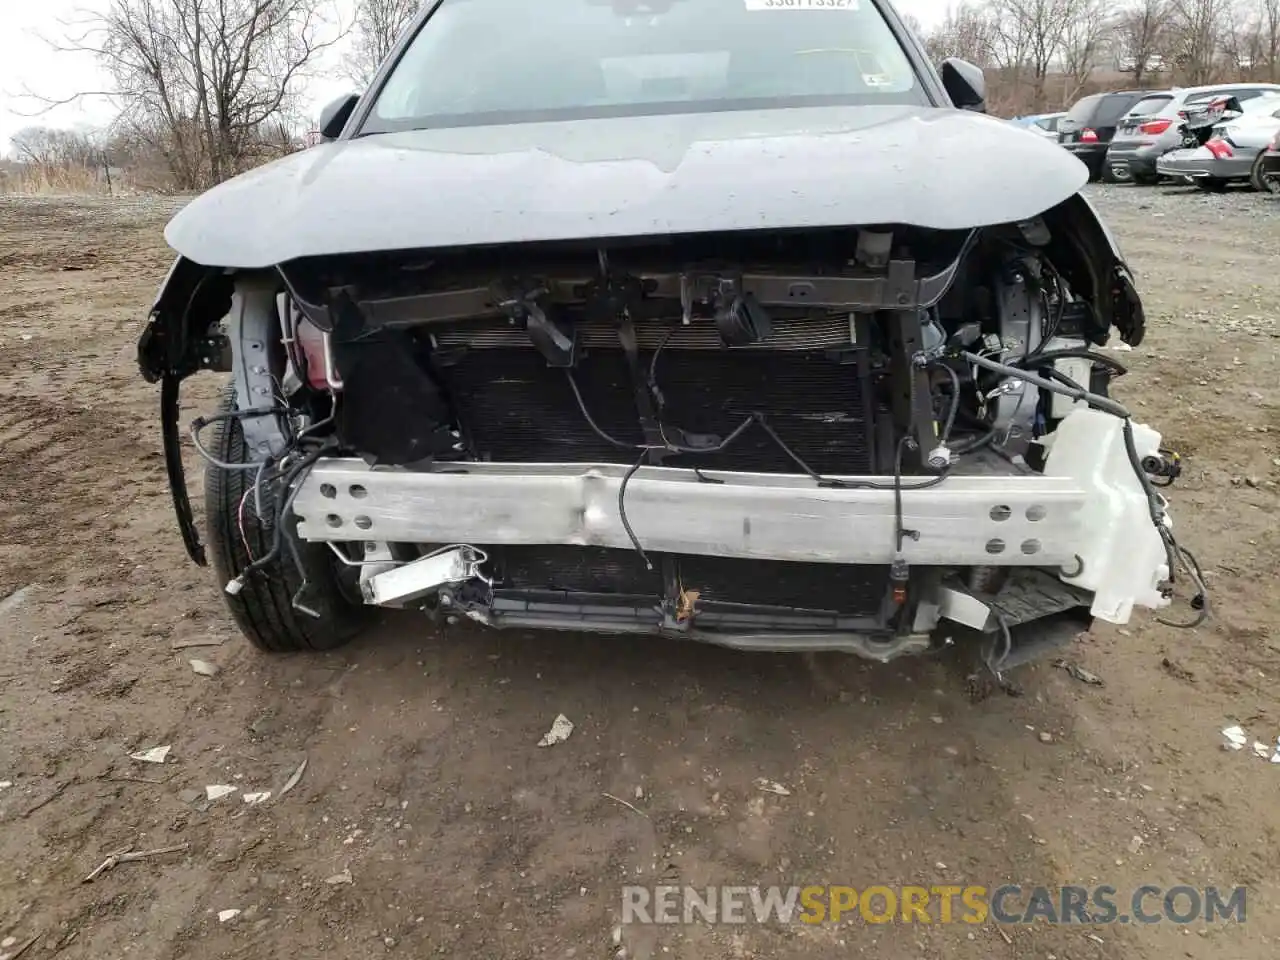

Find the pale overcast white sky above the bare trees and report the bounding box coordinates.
[0,0,948,154]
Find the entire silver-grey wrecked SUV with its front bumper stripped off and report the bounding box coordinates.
[140,0,1197,668]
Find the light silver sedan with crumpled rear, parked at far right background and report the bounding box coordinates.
[1156,93,1280,191]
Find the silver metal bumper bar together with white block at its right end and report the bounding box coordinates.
[294,410,1171,623]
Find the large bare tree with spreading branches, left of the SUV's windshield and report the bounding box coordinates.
[46,0,342,189]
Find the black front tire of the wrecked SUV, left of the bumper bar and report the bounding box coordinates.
[205,385,374,653]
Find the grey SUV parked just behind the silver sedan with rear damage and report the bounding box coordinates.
[1107,83,1280,183]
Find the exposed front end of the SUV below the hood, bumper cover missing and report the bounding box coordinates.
[142,197,1203,658]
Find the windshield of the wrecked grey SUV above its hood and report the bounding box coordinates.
[360,0,929,133]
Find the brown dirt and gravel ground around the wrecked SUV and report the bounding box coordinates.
[0,187,1280,960]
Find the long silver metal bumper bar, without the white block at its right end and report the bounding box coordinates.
[293,460,1089,568]
